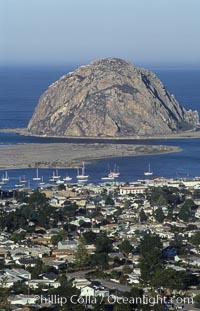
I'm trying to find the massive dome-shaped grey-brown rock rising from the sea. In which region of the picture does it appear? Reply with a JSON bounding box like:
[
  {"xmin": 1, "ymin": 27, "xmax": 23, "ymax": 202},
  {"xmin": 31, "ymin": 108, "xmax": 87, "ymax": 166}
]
[{"xmin": 28, "ymin": 58, "xmax": 199, "ymax": 137}]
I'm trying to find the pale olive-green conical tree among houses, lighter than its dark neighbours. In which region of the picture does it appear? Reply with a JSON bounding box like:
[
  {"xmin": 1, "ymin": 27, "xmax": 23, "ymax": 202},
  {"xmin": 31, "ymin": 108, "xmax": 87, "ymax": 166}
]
[{"xmin": 75, "ymin": 237, "xmax": 89, "ymax": 268}]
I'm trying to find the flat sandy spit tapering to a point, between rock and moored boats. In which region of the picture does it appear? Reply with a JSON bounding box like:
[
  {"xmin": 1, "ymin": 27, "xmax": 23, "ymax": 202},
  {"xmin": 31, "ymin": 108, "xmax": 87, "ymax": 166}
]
[{"xmin": 0, "ymin": 143, "xmax": 181, "ymax": 169}]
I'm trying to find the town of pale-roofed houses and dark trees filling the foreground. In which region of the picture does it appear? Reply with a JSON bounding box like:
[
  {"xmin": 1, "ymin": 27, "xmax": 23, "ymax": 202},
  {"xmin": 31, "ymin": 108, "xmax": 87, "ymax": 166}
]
[{"xmin": 0, "ymin": 177, "xmax": 200, "ymax": 311}]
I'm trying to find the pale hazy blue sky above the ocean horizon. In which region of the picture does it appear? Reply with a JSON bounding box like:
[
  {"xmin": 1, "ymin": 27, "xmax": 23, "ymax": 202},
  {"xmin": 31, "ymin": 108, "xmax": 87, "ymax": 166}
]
[{"xmin": 0, "ymin": 0, "xmax": 200, "ymax": 64}]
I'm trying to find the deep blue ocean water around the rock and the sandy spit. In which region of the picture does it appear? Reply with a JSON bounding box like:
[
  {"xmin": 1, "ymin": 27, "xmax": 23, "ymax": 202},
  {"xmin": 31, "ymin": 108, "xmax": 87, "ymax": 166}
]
[{"xmin": 0, "ymin": 66, "xmax": 200, "ymax": 189}]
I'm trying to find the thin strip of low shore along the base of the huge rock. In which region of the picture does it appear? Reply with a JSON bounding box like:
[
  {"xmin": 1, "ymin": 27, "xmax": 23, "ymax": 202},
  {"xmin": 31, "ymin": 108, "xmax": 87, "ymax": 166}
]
[{"xmin": 0, "ymin": 128, "xmax": 200, "ymax": 141}]
